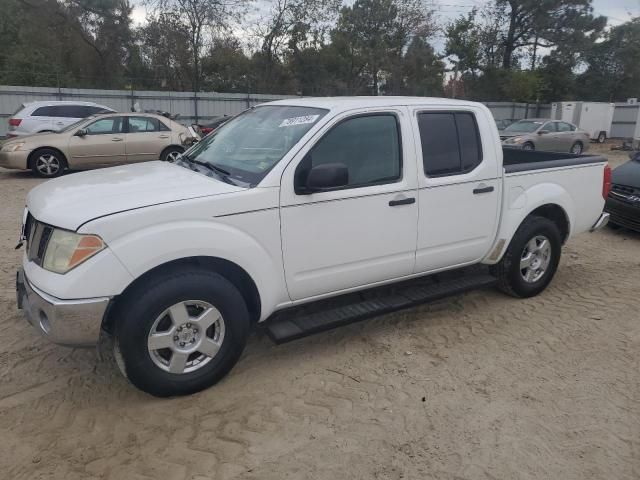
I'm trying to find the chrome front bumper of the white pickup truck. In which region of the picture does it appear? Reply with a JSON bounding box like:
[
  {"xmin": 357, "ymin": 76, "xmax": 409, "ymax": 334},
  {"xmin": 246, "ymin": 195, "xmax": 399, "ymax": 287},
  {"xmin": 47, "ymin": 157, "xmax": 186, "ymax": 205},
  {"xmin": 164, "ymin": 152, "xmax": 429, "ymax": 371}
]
[{"xmin": 16, "ymin": 270, "xmax": 111, "ymax": 347}]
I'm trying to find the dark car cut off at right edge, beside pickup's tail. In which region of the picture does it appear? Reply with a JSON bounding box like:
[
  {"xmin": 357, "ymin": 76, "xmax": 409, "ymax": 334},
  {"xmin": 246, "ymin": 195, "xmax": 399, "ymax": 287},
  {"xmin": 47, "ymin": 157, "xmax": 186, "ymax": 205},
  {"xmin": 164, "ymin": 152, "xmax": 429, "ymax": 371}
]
[{"xmin": 605, "ymin": 152, "xmax": 640, "ymax": 232}]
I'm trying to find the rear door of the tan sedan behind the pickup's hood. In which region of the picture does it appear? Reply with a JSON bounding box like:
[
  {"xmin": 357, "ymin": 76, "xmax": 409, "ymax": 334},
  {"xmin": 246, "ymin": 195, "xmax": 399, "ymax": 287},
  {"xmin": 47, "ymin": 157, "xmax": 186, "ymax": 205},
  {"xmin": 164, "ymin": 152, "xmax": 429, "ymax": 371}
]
[{"xmin": 126, "ymin": 116, "xmax": 171, "ymax": 162}]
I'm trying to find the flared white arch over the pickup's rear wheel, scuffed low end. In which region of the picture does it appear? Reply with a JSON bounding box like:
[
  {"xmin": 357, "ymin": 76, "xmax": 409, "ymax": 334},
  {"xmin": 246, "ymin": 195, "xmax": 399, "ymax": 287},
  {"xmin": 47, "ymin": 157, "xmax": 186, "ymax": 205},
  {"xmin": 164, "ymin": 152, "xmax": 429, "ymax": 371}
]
[{"xmin": 483, "ymin": 182, "xmax": 575, "ymax": 264}]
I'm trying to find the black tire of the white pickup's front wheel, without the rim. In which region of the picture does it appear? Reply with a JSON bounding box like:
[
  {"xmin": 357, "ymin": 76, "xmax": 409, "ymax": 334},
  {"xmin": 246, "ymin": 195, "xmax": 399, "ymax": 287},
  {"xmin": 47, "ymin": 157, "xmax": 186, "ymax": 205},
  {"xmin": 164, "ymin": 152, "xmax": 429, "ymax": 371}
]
[{"xmin": 114, "ymin": 268, "xmax": 250, "ymax": 397}]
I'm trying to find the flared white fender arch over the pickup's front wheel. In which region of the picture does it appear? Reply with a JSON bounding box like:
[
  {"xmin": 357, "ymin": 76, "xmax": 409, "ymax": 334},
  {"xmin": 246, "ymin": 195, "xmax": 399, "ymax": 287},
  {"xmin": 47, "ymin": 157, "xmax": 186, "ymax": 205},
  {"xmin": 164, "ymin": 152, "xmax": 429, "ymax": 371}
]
[{"xmin": 101, "ymin": 218, "xmax": 289, "ymax": 316}]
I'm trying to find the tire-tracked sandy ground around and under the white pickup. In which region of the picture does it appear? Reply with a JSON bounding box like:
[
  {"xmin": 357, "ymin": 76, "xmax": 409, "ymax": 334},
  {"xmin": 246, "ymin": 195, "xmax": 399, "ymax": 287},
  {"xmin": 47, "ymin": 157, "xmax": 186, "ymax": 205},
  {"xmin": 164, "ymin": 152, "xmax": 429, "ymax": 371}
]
[{"xmin": 0, "ymin": 143, "xmax": 640, "ymax": 480}]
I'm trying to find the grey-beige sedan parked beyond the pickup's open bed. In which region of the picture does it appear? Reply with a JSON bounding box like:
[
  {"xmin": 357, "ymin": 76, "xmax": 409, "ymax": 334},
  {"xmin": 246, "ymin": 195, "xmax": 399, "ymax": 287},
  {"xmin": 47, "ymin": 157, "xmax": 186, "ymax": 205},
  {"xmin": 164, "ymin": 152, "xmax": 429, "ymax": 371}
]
[{"xmin": 500, "ymin": 118, "xmax": 590, "ymax": 155}]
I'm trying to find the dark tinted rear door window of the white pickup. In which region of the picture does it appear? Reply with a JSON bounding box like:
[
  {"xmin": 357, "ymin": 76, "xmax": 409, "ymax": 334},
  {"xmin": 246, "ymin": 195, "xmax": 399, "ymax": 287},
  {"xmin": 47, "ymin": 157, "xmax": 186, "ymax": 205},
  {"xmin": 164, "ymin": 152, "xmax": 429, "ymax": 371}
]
[{"xmin": 418, "ymin": 112, "xmax": 482, "ymax": 177}]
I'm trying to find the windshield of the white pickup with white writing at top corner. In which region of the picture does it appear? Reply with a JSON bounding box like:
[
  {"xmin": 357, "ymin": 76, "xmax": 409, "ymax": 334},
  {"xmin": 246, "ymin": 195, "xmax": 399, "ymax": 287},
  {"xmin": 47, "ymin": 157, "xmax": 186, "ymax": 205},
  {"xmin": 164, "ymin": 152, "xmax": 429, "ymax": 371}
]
[{"xmin": 185, "ymin": 105, "xmax": 328, "ymax": 186}]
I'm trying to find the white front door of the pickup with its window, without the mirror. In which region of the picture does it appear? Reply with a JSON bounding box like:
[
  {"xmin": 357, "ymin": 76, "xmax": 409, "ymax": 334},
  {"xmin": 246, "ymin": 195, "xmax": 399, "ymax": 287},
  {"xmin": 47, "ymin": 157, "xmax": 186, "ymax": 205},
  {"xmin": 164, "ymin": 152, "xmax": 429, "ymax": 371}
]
[{"xmin": 280, "ymin": 109, "xmax": 418, "ymax": 300}]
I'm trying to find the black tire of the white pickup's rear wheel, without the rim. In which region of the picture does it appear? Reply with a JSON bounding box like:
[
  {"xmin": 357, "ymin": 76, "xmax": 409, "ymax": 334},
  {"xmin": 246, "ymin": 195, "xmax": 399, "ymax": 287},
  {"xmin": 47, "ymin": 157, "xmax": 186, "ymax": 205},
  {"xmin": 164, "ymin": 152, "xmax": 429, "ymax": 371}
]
[{"xmin": 491, "ymin": 216, "xmax": 562, "ymax": 298}]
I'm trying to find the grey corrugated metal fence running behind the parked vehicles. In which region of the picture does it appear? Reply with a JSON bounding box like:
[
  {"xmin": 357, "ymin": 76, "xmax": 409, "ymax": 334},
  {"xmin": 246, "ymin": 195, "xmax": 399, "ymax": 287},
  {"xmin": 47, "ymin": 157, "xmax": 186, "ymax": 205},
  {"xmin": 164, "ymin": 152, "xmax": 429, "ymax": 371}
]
[{"xmin": 0, "ymin": 86, "xmax": 640, "ymax": 138}]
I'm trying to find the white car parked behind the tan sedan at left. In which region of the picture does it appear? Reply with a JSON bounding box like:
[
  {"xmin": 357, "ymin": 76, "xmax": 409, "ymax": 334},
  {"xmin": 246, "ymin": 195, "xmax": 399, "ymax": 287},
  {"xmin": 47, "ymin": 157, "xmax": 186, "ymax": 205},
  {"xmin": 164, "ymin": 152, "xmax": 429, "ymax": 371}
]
[{"xmin": 7, "ymin": 101, "xmax": 114, "ymax": 137}]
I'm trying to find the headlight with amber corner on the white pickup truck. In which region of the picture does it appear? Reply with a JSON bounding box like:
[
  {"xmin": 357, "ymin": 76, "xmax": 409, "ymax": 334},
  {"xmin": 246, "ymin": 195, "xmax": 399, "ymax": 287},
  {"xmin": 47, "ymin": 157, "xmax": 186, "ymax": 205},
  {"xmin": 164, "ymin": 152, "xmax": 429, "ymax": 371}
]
[{"xmin": 42, "ymin": 228, "xmax": 105, "ymax": 273}]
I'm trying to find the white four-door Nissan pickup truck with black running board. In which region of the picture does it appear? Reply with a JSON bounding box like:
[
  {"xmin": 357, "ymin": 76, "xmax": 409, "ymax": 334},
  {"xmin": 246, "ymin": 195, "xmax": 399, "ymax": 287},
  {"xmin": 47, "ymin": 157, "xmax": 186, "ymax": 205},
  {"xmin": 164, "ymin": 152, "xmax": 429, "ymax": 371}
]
[{"xmin": 17, "ymin": 97, "xmax": 610, "ymax": 396}]
